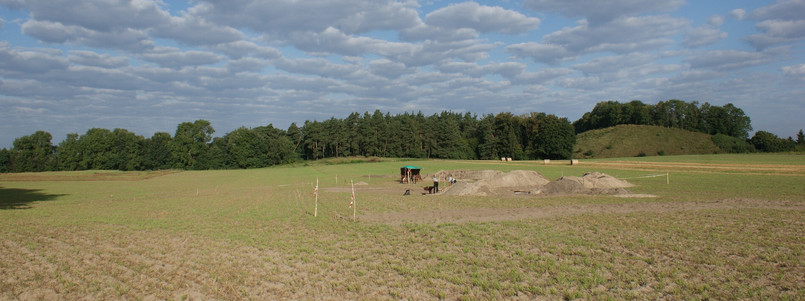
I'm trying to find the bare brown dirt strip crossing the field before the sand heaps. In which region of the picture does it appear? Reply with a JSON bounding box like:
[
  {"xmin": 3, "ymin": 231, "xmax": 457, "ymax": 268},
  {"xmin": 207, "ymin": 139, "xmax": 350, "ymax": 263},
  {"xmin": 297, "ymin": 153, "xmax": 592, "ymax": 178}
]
[{"xmin": 358, "ymin": 199, "xmax": 805, "ymax": 224}]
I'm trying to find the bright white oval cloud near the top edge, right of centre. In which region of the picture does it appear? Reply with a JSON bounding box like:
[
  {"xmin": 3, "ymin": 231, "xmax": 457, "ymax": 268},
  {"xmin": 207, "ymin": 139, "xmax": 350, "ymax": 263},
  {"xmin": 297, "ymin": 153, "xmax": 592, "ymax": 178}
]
[{"xmin": 425, "ymin": 2, "xmax": 540, "ymax": 33}]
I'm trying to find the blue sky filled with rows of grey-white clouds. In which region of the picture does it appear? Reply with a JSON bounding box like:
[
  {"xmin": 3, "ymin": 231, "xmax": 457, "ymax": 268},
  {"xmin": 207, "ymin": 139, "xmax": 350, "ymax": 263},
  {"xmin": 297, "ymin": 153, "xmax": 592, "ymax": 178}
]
[{"xmin": 0, "ymin": 0, "xmax": 805, "ymax": 148}]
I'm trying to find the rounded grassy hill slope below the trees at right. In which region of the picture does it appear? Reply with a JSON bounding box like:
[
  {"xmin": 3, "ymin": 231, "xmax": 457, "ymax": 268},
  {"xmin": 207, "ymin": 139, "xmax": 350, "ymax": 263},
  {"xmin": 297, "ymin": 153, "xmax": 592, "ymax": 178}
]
[{"xmin": 573, "ymin": 125, "xmax": 720, "ymax": 158}]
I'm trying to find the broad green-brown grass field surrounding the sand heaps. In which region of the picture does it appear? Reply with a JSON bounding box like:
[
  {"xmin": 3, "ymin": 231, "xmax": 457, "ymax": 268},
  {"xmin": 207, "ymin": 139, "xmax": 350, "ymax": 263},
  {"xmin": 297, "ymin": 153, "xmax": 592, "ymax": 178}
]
[{"xmin": 0, "ymin": 155, "xmax": 805, "ymax": 300}]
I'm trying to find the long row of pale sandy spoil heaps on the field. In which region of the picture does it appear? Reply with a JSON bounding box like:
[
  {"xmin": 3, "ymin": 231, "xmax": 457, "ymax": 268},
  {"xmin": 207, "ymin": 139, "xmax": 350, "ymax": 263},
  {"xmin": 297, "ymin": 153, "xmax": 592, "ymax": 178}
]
[{"xmin": 435, "ymin": 170, "xmax": 633, "ymax": 196}]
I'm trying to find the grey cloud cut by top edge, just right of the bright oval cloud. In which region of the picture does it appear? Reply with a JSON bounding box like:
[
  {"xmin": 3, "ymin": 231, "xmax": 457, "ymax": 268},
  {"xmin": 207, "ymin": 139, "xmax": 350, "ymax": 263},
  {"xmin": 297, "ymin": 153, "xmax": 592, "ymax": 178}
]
[{"xmin": 523, "ymin": 0, "xmax": 685, "ymax": 25}]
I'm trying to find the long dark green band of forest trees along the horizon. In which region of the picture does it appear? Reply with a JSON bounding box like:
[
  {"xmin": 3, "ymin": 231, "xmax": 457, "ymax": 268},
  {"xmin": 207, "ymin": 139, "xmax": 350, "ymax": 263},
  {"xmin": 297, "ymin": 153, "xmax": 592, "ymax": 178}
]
[{"xmin": 0, "ymin": 100, "xmax": 805, "ymax": 172}]
